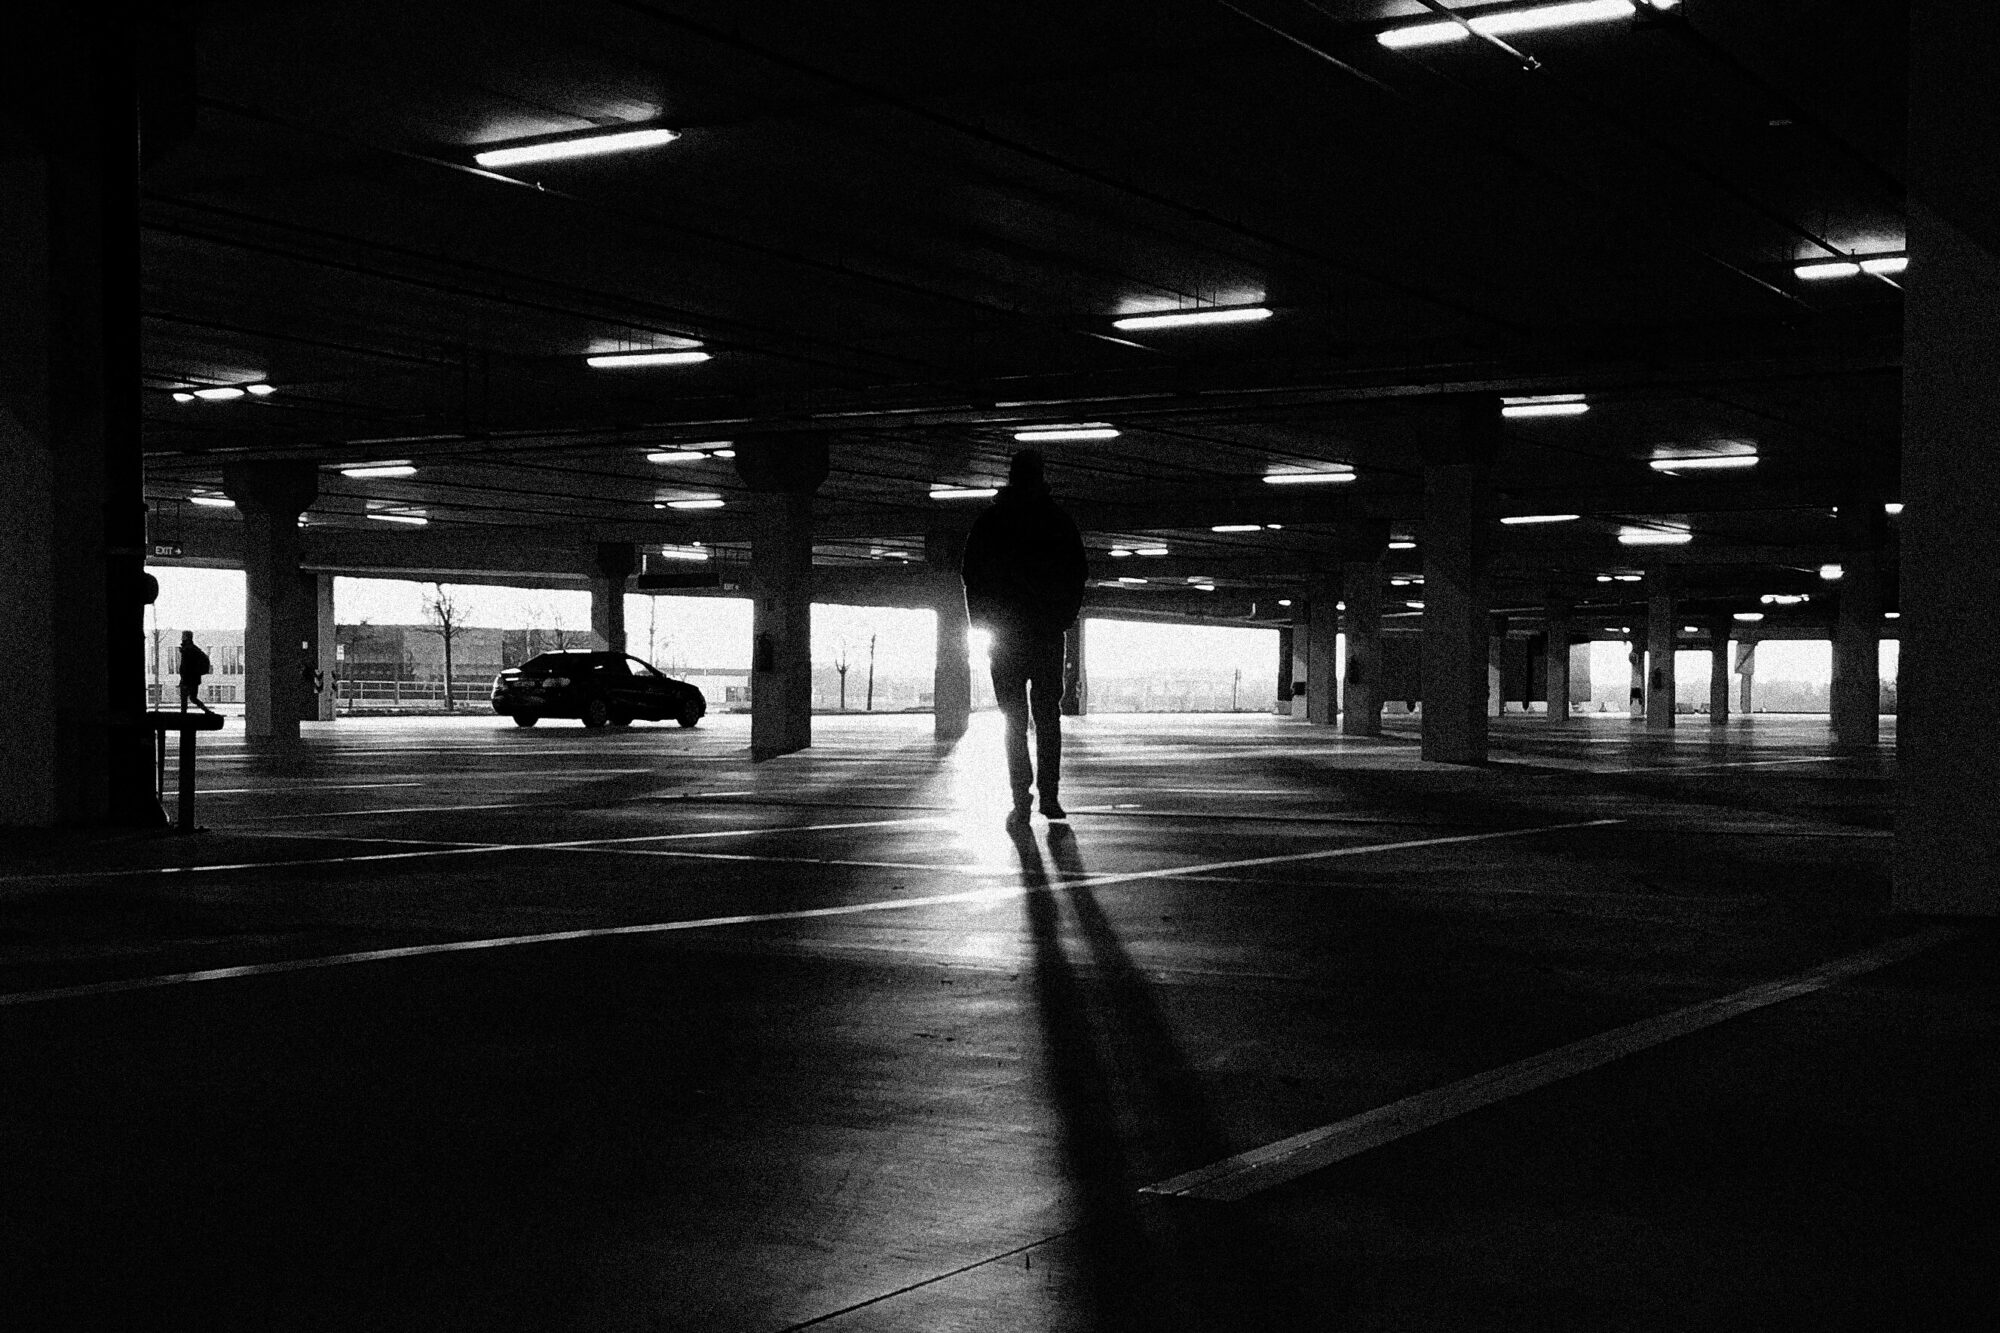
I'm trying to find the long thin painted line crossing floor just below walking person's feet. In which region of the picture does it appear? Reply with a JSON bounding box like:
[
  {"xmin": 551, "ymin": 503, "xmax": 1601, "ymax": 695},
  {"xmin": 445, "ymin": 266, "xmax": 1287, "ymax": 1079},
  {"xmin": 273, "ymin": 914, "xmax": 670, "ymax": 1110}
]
[{"xmin": 0, "ymin": 819, "xmax": 1622, "ymax": 1007}]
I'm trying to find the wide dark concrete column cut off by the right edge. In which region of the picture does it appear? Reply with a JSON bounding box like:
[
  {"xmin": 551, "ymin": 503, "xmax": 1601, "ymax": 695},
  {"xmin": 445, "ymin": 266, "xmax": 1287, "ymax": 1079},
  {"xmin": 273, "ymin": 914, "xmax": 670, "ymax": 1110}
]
[{"xmin": 1894, "ymin": 0, "xmax": 2000, "ymax": 917}]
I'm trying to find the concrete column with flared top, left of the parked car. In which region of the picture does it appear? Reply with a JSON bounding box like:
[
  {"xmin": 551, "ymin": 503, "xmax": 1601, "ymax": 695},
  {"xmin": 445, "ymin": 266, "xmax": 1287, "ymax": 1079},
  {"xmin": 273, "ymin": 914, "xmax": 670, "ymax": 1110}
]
[{"xmin": 222, "ymin": 462, "xmax": 320, "ymax": 743}]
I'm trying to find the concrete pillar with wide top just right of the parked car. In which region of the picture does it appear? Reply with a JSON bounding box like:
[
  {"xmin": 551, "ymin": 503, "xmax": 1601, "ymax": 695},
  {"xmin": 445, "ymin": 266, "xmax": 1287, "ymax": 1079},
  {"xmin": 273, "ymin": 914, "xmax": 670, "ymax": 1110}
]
[{"xmin": 736, "ymin": 434, "xmax": 828, "ymax": 763}]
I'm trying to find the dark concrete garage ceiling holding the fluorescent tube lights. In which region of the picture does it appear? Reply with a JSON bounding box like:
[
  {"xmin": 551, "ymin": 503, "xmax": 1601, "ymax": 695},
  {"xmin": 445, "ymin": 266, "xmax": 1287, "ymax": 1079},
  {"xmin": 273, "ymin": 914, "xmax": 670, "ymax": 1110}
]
[{"xmin": 142, "ymin": 0, "xmax": 1906, "ymax": 614}]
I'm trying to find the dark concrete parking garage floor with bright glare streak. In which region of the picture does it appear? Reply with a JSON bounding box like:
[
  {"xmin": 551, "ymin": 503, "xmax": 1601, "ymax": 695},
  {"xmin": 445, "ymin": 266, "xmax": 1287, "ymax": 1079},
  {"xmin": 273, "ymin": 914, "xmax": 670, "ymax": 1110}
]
[{"xmin": 0, "ymin": 715, "xmax": 2000, "ymax": 1333}]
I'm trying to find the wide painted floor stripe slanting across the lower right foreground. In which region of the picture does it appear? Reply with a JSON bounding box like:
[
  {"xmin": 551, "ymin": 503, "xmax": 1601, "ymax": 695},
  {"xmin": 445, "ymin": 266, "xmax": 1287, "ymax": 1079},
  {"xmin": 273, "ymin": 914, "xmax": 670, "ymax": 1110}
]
[{"xmin": 1140, "ymin": 927, "xmax": 1962, "ymax": 1203}]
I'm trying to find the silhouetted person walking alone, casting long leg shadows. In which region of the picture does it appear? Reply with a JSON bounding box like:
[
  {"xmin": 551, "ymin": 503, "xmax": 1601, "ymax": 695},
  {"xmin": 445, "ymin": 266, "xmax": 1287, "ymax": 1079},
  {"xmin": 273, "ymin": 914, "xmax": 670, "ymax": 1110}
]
[{"xmin": 962, "ymin": 448, "xmax": 1088, "ymax": 819}]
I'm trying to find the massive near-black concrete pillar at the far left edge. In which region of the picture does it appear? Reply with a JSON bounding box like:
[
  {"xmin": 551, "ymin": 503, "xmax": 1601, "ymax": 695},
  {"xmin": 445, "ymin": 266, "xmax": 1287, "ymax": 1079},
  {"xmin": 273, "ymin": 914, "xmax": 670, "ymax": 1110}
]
[{"xmin": 0, "ymin": 23, "xmax": 166, "ymax": 827}]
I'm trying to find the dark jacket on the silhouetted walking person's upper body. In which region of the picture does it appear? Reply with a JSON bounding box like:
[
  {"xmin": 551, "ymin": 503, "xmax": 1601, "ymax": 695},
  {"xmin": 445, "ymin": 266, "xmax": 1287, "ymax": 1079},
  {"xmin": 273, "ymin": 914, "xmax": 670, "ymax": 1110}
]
[{"xmin": 962, "ymin": 486, "xmax": 1090, "ymax": 642}]
